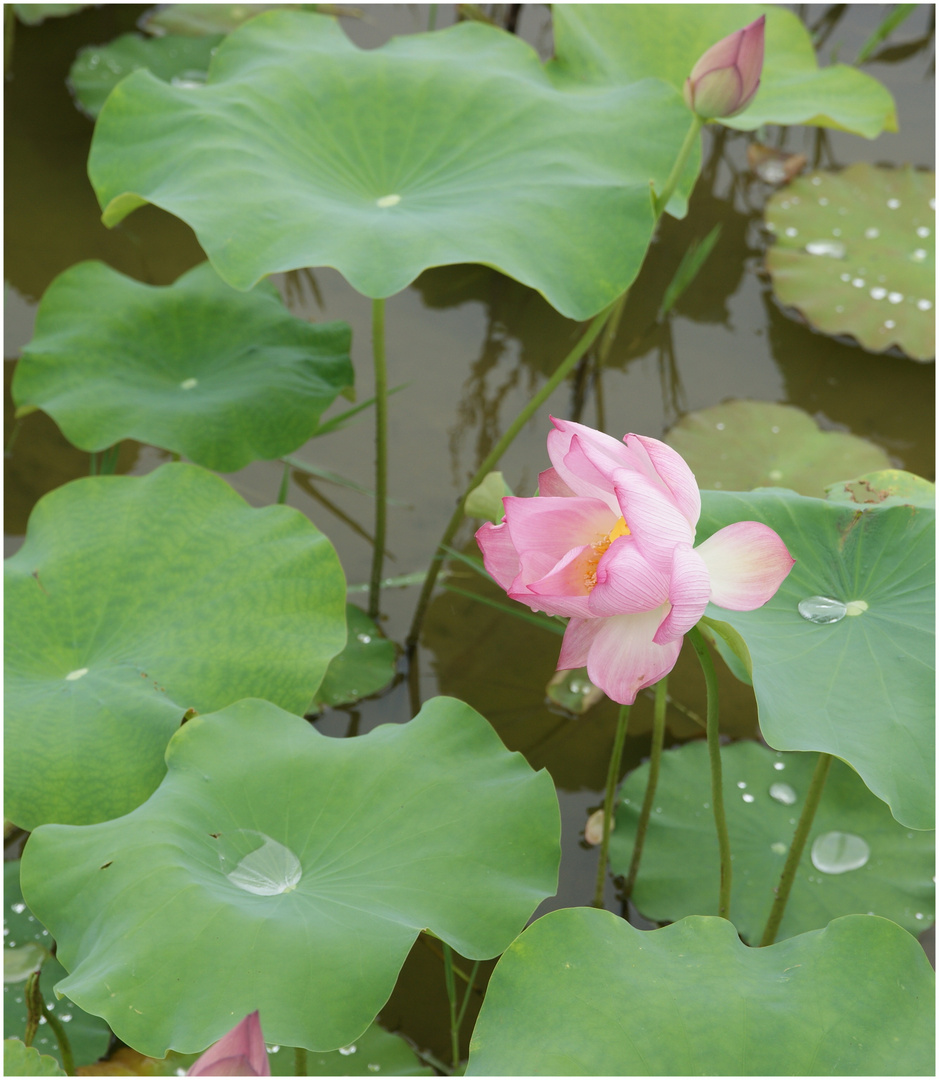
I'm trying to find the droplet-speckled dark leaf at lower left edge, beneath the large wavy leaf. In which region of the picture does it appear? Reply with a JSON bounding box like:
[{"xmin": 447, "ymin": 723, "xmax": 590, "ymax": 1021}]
[{"xmin": 3, "ymin": 859, "xmax": 111, "ymax": 1076}]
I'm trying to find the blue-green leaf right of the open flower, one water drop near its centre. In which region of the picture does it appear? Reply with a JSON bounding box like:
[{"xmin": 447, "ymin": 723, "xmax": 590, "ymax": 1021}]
[{"xmin": 698, "ymin": 490, "xmax": 935, "ymax": 829}]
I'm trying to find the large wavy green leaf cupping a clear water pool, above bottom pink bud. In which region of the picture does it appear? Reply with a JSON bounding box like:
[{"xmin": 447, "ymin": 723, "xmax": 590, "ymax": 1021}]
[{"xmin": 22, "ymin": 698, "xmax": 560, "ymax": 1056}]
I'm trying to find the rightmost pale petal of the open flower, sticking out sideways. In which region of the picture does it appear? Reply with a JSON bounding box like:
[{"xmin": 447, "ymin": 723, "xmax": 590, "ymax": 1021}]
[{"xmin": 695, "ymin": 522, "xmax": 795, "ymax": 611}]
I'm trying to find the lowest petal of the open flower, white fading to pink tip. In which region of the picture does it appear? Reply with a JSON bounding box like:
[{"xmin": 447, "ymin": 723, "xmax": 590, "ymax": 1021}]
[{"xmin": 578, "ymin": 605, "xmax": 682, "ymax": 705}]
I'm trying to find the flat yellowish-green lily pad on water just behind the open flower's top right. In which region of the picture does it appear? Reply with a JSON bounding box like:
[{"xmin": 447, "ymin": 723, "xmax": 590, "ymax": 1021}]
[{"xmin": 666, "ymin": 401, "xmax": 890, "ymax": 498}]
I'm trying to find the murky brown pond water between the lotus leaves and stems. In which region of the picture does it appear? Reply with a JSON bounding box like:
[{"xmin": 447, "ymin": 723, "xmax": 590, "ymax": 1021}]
[{"xmin": 5, "ymin": 4, "xmax": 935, "ymax": 1056}]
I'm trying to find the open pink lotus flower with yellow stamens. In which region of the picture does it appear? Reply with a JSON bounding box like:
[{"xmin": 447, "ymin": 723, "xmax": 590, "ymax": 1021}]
[{"xmin": 477, "ymin": 417, "xmax": 794, "ymax": 705}]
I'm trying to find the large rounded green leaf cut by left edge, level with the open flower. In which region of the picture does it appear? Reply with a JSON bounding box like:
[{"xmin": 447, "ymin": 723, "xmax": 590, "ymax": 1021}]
[{"xmin": 4, "ymin": 464, "xmax": 346, "ymax": 825}]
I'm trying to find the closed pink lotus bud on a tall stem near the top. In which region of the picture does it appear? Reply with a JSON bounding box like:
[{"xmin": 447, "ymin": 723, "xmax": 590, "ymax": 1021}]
[{"xmin": 684, "ymin": 15, "xmax": 766, "ymax": 120}]
